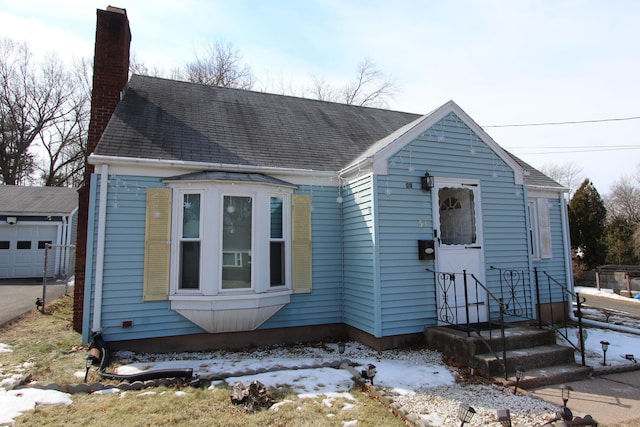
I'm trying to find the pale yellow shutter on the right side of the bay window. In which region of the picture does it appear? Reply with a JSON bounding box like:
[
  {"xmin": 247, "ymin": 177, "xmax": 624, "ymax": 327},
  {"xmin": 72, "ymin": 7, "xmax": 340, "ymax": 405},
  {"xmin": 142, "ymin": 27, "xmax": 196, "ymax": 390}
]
[{"xmin": 291, "ymin": 194, "xmax": 312, "ymax": 294}]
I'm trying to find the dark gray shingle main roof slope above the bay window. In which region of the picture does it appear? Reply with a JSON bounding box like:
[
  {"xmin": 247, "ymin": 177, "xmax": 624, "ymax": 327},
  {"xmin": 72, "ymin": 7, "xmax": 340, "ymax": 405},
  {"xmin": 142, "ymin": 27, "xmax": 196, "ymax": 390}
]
[{"xmin": 95, "ymin": 75, "xmax": 419, "ymax": 171}]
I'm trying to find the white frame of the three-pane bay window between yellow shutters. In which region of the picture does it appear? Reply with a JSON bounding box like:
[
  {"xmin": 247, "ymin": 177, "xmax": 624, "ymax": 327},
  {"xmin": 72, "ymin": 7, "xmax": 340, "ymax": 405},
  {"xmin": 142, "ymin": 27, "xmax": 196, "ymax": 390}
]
[{"xmin": 169, "ymin": 181, "xmax": 293, "ymax": 301}]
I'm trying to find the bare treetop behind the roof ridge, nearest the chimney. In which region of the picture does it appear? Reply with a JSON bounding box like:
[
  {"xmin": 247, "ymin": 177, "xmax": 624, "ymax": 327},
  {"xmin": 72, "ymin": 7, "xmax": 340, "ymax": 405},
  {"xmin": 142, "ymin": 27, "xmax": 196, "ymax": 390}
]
[{"xmin": 185, "ymin": 42, "xmax": 254, "ymax": 89}]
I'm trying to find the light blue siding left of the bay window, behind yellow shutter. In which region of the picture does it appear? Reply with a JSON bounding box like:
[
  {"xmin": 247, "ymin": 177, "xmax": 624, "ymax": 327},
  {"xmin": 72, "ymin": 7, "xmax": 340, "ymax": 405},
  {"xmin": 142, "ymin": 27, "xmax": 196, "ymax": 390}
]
[{"xmin": 83, "ymin": 175, "xmax": 202, "ymax": 341}]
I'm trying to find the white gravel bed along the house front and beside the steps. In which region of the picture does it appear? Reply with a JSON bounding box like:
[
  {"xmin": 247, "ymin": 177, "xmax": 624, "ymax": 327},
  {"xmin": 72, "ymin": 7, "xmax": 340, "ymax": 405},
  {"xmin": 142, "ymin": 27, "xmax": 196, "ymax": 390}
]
[{"xmin": 117, "ymin": 342, "xmax": 559, "ymax": 426}]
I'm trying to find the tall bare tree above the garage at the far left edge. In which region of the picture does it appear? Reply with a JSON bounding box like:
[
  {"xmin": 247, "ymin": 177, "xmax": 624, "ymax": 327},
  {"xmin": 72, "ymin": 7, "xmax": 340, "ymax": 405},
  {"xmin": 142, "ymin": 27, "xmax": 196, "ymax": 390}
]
[{"xmin": 0, "ymin": 39, "xmax": 86, "ymax": 185}]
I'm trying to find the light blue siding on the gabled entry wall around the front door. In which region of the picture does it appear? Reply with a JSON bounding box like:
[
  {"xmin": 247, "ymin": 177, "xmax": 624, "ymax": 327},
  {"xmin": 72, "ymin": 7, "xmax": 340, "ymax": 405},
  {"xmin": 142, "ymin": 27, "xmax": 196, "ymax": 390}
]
[{"xmin": 376, "ymin": 113, "xmax": 529, "ymax": 336}]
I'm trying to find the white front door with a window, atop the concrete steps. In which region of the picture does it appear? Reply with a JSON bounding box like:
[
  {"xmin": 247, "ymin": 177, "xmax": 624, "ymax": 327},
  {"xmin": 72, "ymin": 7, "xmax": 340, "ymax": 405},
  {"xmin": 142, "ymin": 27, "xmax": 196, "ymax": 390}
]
[{"xmin": 432, "ymin": 179, "xmax": 488, "ymax": 324}]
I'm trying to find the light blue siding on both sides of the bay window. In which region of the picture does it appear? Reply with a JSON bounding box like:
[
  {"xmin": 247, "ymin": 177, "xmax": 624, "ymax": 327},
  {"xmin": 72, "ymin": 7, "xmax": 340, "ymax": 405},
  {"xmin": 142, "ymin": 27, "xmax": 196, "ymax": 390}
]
[{"xmin": 86, "ymin": 176, "xmax": 342, "ymax": 340}]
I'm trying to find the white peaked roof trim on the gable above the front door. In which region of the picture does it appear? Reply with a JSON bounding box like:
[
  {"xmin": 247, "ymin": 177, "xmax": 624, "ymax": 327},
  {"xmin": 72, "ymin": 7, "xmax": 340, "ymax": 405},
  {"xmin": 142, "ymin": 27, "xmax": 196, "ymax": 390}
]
[{"xmin": 338, "ymin": 101, "xmax": 524, "ymax": 185}]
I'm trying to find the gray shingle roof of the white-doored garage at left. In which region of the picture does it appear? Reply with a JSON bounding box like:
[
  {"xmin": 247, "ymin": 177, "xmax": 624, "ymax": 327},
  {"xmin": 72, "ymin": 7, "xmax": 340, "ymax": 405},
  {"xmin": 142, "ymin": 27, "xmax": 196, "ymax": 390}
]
[{"xmin": 0, "ymin": 185, "xmax": 78, "ymax": 215}]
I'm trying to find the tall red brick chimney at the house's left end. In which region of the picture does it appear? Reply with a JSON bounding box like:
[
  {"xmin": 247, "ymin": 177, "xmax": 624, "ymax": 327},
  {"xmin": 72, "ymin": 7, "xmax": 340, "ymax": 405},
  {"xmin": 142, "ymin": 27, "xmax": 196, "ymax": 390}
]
[{"xmin": 73, "ymin": 6, "xmax": 131, "ymax": 332}]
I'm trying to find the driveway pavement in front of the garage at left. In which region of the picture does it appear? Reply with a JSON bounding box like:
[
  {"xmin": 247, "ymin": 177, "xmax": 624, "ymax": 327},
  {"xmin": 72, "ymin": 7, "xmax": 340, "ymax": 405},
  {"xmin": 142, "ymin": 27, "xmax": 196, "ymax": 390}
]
[{"xmin": 0, "ymin": 278, "xmax": 70, "ymax": 326}]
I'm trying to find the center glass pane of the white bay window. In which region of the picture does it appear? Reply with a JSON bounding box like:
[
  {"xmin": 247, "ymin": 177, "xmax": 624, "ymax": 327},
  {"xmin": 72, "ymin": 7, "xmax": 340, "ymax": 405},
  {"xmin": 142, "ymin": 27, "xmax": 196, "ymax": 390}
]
[{"xmin": 222, "ymin": 196, "xmax": 253, "ymax": 289}]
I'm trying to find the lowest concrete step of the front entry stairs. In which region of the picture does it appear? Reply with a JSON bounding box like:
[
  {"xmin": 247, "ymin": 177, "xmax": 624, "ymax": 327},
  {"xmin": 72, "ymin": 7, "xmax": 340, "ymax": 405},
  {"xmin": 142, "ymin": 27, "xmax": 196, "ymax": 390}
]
[{"xmin": 495, "ymin": 363, "xmax": 593, "ymax": 390}]
